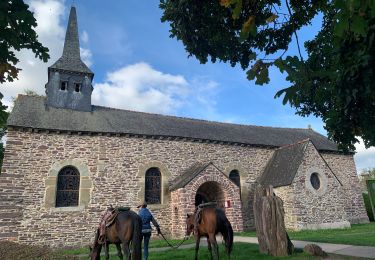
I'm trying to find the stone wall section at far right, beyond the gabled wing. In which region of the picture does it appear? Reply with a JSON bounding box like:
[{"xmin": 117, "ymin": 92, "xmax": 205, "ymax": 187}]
[{"xmin": 322, "ymin": 153, "xmax": 369, "ymax": 224}]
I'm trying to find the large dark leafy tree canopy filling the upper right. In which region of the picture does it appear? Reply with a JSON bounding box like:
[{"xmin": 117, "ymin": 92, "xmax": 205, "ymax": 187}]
[{"xmin": 160, "ymin": 0, "xmax": 375, "ymax": 150}]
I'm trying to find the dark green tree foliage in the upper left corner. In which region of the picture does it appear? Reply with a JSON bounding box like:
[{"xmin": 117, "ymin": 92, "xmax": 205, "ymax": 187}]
[{"xmin": 0, "ymin": 0, "xmax": 49, "ymax": 83}]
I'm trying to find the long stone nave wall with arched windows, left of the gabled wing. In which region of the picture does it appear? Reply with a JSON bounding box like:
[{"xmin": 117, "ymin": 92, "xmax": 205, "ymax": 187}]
[{"xmin": 0, "ymin": 129, "xmax": 272, "ymax": 246}]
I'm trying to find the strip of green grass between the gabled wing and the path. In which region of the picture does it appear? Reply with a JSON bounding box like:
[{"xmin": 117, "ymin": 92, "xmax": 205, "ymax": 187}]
[{"xmin": 237, "ymin": 223, "xmax": 375, "ymax": 246}]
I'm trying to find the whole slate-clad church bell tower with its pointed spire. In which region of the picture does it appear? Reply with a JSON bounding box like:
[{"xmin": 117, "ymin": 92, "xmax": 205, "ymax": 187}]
[{"xmin": 46, "ymin": 6, "xmax": 94, "ymax": 112}]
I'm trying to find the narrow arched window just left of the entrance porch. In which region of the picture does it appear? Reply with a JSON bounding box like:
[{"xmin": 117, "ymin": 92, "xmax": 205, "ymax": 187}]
[{"xmin": 145, "ymin": 167, "xmax": 161, "ymax": 204}]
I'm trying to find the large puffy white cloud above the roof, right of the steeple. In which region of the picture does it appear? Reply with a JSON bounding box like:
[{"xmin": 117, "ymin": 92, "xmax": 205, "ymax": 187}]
[{"xmin": 92, "ymin": 62, "xmax": 217, "ymax": 116}]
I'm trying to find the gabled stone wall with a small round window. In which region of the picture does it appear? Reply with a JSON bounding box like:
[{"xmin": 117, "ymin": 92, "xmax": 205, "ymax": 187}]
[{"xmin": 275, "ymin": 142, "xmax": 350, "ymax": 230}]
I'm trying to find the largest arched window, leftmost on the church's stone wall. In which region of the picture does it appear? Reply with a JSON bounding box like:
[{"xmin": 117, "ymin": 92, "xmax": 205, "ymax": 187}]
[{"xmin": 56, "ymin": 166, "xmax": 80, "ymax": 207}]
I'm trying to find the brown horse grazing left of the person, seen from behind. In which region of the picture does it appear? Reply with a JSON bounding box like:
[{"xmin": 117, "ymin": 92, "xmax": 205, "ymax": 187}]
[{"xmin": 90, "ymin": 210, "xmax": 142, "ymax": 260}]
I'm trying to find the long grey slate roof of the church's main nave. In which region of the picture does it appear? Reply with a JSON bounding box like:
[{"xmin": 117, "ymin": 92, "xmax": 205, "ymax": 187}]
[{"xmin": 8, "ymin": 95, "xmax": 338, "ymax": 152}]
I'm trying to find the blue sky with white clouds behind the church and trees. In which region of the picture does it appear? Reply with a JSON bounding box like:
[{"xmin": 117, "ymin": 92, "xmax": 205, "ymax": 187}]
[{"xmin": 0, "ymin": 0, "xmax": 375, "ymax": 171}]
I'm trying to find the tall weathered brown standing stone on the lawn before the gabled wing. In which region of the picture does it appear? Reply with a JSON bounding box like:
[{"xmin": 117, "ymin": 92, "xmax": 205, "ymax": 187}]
[{"xmin": 253, "ymin": 185, "xmax": 294, "ymax": 256}]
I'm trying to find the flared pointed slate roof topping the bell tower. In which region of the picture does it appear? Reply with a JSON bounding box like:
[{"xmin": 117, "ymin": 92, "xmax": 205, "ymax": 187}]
[{"xmin": 49, "ymin": 7, "xmax": 94, "ymax": 75}]
